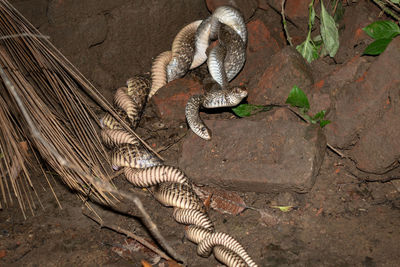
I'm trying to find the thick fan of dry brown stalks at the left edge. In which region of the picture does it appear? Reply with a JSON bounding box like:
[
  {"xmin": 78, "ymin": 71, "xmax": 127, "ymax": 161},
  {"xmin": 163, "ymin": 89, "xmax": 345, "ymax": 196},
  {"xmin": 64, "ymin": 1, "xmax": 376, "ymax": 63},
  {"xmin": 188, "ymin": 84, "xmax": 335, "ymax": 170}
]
[{"xmin": 0, "ymin": 1, "xmax": 115, "ymax": 216}]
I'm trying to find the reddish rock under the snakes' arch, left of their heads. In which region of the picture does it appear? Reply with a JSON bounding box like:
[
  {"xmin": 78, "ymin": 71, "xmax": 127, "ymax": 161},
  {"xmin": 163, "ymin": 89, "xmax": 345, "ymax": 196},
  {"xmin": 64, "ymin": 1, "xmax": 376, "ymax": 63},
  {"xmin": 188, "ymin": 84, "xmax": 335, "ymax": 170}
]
[{"xmin": 151, "ymin": 78, "xmax": 203, "ymax": 121}]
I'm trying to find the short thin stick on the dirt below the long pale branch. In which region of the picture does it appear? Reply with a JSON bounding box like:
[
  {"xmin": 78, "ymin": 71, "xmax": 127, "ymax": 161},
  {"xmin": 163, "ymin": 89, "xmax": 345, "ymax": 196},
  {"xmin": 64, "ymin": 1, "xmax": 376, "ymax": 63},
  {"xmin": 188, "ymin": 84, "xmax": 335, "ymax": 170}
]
[{"xmin": 82, "ymin": 206, "xmax": 172, "ymax": 260}]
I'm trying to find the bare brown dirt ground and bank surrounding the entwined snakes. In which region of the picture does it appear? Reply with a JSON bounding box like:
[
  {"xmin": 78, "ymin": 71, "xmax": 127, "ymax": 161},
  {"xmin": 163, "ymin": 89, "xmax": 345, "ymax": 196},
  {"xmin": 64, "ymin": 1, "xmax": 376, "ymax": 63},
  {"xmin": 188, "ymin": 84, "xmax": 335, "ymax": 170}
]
[{"xmin": 0, "ymin": 0, "xmax": 400, "ymax": 267}]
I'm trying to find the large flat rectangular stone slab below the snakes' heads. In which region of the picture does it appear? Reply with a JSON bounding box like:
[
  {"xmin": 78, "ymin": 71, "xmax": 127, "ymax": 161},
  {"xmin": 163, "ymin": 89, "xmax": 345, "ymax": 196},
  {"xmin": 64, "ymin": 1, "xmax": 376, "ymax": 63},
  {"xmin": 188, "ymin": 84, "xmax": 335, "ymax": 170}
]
[{"xmin": 179, "ymin": 109, "xmax": 326, "ymax": 192}]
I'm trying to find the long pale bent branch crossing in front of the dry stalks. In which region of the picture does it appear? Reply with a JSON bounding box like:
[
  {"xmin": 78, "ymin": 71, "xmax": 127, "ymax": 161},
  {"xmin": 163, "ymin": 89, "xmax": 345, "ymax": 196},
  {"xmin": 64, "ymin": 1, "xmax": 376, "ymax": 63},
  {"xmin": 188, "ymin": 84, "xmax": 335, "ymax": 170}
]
[{"xmin": 0, "ymin": 67, "xmax": 184, "ymax": 262}]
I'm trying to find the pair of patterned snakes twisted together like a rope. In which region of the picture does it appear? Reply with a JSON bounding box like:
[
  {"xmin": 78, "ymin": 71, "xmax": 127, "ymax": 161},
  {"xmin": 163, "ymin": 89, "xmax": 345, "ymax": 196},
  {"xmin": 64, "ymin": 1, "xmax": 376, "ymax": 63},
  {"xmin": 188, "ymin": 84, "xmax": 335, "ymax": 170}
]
[{"xmin": 100, "ymin": 6, "xmax": 257, "ymax": 266}]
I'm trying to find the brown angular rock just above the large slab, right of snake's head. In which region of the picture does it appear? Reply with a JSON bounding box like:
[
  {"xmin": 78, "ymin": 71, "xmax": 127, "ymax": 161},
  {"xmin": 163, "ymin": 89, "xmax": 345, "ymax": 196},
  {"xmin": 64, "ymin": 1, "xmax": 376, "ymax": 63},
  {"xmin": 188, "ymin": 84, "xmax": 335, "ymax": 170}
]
[{"xmin": 248, "ymin": 46, "xmax": 313, "ymax": 105}]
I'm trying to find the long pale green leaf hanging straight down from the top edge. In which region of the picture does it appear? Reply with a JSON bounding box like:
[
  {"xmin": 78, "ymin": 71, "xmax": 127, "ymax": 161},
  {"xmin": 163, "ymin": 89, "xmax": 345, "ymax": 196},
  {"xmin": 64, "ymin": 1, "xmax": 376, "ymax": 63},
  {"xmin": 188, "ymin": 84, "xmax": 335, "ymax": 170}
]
[{"xmin": 321, "ymin": 1, "xmax": 339, "ymax": 57}]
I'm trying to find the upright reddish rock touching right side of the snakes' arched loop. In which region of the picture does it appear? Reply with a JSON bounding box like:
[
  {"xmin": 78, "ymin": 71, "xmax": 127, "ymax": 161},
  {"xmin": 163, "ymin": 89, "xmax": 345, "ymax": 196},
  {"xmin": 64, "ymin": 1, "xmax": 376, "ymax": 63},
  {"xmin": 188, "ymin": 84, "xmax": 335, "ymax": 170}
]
[{"xmin": 234, "ymin": 19, "xmax": 282, "ymax": 85}]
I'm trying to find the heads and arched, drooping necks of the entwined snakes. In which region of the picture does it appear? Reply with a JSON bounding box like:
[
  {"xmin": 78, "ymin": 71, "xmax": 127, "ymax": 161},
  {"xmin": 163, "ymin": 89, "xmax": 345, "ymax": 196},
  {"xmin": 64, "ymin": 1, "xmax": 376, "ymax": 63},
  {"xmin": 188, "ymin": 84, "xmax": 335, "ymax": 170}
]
[{"xmin": 185, "ymin": 6, "xmax": 247, "ymax": 140}]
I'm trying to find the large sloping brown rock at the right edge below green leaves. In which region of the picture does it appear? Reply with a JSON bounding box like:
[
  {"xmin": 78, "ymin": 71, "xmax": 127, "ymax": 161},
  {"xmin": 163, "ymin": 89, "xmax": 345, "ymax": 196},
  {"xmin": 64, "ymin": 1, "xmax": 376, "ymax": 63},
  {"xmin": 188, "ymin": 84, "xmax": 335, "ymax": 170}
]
[{"xmin": 326, "ymin": 37, "xmax": 400, "ymax": 149}]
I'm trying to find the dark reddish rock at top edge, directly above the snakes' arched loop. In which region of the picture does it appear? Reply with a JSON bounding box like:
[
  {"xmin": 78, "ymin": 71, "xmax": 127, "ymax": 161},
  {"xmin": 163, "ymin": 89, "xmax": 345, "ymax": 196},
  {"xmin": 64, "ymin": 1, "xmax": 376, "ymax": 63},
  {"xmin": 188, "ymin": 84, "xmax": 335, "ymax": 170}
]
[{"xmin": 206, "ymin": 0, "xmax": 258, "ymax": 20}]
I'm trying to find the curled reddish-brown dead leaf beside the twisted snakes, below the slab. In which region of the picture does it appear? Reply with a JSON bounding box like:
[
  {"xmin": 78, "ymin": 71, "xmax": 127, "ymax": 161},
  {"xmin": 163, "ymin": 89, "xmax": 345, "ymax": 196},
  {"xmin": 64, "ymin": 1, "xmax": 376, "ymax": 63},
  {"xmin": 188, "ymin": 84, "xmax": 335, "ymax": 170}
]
[{"xmin": 193, "ymin": 186, "xmax": 247, "ymax": 215}]
